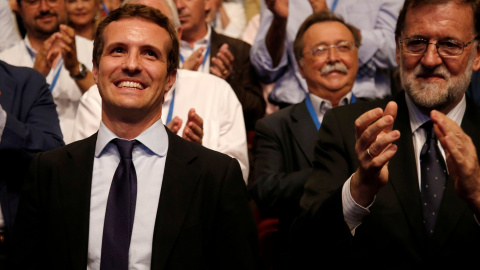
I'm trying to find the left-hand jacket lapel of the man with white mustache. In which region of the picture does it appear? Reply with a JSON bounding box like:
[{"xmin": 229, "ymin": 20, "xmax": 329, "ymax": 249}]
[{"xmin": 290, "ymin": 100, "xmax": 318, "ymax": 166}]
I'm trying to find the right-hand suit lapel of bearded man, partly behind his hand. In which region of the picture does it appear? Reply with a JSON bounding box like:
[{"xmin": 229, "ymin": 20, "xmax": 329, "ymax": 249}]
[{"xmin": 433, "ymin": 99, "xmax": 480, "ymax": 245}]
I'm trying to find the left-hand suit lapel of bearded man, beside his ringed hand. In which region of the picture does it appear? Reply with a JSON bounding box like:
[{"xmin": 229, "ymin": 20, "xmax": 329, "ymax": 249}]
[{"xmin": 388, "ymin": 91, "xmax": 425, "ymax": 243}]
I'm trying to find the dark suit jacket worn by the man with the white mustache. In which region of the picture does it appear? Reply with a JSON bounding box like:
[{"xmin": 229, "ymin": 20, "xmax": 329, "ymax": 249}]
[{"xmin": 249, "ymin": 100, "xmax": 318, "ymax": 224}]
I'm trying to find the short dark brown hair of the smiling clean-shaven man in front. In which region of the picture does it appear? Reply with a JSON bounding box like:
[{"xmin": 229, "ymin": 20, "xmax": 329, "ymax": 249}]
[{"xmin": 93, "ymin": 4, "xmax": 180, "ymax": 72}]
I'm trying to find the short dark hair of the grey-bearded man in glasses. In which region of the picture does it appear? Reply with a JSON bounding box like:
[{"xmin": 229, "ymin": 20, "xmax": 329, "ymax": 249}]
[{"xmin": 395, "ymin": 0, "xmax": 480, "ymax": 37}]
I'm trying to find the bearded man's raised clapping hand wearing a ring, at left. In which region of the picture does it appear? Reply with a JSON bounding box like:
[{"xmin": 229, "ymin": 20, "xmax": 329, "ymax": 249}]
[{"xmin": 350, "ymin": 102, "xmax": 400, "ymax": 207}]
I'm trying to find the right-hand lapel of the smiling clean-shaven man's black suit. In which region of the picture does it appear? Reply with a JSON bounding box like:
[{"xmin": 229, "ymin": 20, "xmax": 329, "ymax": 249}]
[{"xmin": 151, "ymin": 129, "xmax": 200, "ymax": 269}]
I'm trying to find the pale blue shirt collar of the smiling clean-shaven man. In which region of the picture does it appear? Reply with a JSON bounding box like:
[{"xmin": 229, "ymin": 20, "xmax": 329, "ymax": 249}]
[{"xmin": 95, "ymin": 119, "xmax": 168, "ymax": 158}]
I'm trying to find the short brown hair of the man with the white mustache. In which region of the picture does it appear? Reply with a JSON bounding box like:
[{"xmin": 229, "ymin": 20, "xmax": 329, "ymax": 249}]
[{"xmin": 293, "ymin": 11, "xmax": 360, "ymax": 61}]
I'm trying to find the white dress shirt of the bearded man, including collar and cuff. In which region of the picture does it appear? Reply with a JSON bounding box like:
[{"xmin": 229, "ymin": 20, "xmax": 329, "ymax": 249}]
[{"xmin": 342, "ymin": 93, "xmax": 467, "ymax": 234}]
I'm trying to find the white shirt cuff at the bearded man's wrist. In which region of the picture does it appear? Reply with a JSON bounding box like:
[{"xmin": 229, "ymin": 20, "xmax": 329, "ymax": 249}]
[{"xmin": 342, "ymin": 174, "xmax": 375, "ymax": 235}]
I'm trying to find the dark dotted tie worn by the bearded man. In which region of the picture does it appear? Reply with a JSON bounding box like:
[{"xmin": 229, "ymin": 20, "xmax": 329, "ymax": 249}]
[{"xmin": 420, "ymin": 121, "xmax": 447, "ymax": 235}]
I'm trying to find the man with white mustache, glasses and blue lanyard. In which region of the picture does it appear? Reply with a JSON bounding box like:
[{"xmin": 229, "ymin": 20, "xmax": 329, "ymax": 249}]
[{"xmin": 250, "ymin": 12, "xmax": 360, "ymax": 269}]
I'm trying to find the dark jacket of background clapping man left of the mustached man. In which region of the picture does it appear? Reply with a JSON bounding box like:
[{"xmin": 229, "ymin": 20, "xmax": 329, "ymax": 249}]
[{"xmin": 210, "ymin": 29, "xmax": 266, "ymax": 130}]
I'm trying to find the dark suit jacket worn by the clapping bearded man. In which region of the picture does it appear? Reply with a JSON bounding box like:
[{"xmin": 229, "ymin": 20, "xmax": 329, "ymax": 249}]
[{"xmin": 292, "ymin": 91, "xmax": 480, "ymax": 269}]
